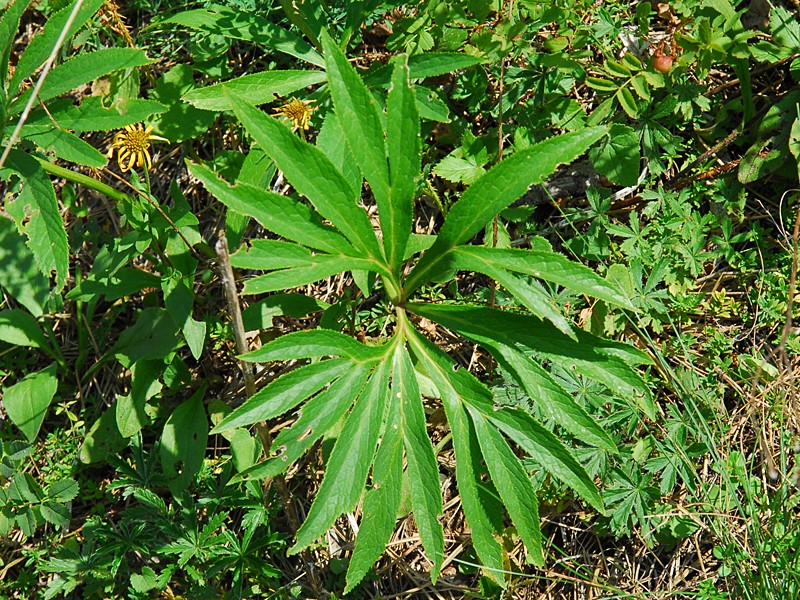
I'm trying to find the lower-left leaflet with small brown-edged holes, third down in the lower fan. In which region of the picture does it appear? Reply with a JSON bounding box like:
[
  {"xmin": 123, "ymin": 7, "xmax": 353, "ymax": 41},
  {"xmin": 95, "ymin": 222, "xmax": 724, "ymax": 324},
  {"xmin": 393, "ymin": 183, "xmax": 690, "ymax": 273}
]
[{"xmin": 230, "ymin": 365, "xmax": 372, "ymax": 480}]
